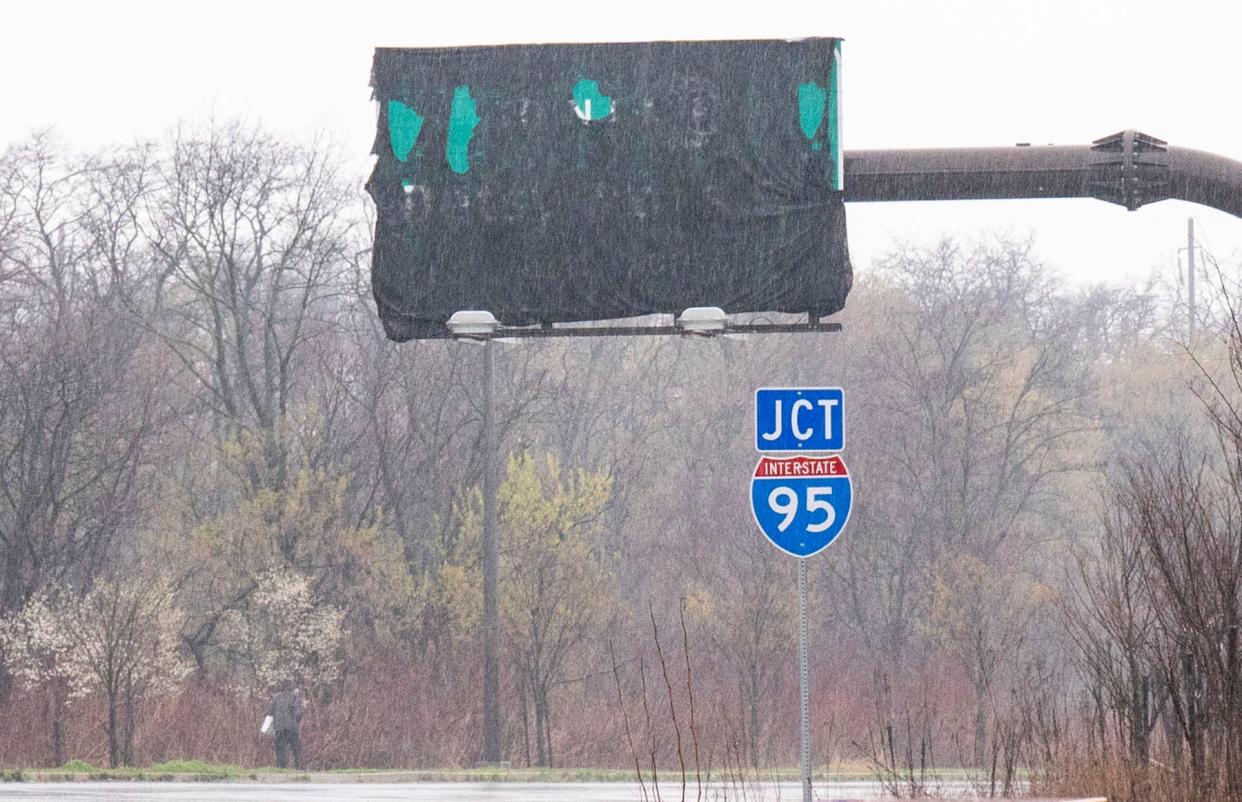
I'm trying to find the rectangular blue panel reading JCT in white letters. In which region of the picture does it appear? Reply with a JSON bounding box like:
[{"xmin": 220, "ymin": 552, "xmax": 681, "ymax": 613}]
[{"xmin": 755, "ymin": 387, "xmax": 845, "ymax": 452}]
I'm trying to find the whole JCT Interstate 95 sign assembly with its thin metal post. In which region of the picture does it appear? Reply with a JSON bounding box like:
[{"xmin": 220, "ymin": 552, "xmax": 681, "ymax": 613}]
[{"xmin": 750, "ymin": 387, "xmax": 853, "ymax": 802}]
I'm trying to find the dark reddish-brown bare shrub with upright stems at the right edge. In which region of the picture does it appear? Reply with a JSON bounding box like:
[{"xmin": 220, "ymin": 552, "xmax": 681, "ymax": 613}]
[{"xmin": 1067, "ymin": 260, "xmax": 1242, "ymax": 800}]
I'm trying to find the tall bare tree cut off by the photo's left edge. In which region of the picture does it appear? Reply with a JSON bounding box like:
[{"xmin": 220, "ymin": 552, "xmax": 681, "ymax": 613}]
[{"xmin": 0, "ymin": 137, "xmax": 160, "ymax": 610}]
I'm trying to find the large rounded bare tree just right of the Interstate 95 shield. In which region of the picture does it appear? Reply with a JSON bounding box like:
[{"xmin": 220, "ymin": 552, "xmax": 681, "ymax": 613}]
[{"xmin": 833, "ymin": 242, "xmax": 1094, "ymax": 668}]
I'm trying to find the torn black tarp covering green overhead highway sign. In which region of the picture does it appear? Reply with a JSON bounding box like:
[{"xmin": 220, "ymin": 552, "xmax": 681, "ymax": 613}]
[{"xmin": 368, "ymin": 38, "xmax": 852, "ymax": 340}]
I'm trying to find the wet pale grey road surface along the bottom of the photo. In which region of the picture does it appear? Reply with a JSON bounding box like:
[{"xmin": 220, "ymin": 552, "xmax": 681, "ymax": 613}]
[{"xmin": 0, "ymin": 782, "xmax": 948, "ymax": 802}]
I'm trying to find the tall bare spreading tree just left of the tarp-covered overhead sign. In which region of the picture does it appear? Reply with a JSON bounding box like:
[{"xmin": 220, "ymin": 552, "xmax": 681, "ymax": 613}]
[{"xmin": 147, "ymin": 124, "xmax": 356, "ymax": 489}]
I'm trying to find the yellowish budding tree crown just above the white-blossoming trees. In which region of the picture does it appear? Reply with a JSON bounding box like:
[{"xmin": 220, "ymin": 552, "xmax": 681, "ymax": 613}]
[{"xmin": 148, "ymin": 437, "xmax": 412, "ymax": 670}]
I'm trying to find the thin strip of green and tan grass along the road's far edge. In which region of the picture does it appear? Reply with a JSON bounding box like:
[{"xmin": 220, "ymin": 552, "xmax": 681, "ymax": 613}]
[{"xmin": 0, "ymin": 760, "xmax": 977, "ymax": 782}]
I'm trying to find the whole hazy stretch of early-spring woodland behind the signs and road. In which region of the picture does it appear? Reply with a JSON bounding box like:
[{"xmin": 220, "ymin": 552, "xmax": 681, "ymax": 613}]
[{"xmin": 0, "ymin": 125, "xmax": 1242, "ymax": 798}]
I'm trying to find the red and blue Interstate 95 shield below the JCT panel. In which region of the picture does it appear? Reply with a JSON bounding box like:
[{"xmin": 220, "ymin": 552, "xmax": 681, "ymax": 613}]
[{"xmin": 750, "ymin": 454, "xmax": 853, "ymax": 557}]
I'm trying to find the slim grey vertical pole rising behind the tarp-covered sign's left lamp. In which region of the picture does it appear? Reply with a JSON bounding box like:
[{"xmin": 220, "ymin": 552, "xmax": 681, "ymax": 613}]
[{"xmin": 483, "ymin": 338, "xmax": 501, "ymax": 765}]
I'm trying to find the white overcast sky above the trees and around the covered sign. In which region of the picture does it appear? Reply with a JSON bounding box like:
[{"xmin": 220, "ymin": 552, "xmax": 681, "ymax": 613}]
[{"xmin": 0, "ymin": 0, "xmax": 1242, "ymax": 289}]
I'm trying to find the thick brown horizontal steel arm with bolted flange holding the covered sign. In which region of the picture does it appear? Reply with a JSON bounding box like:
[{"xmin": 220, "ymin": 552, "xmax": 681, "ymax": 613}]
[{"xmin": 845, "ymin": 130, "xmax": 1242, "ymax": 217}]
